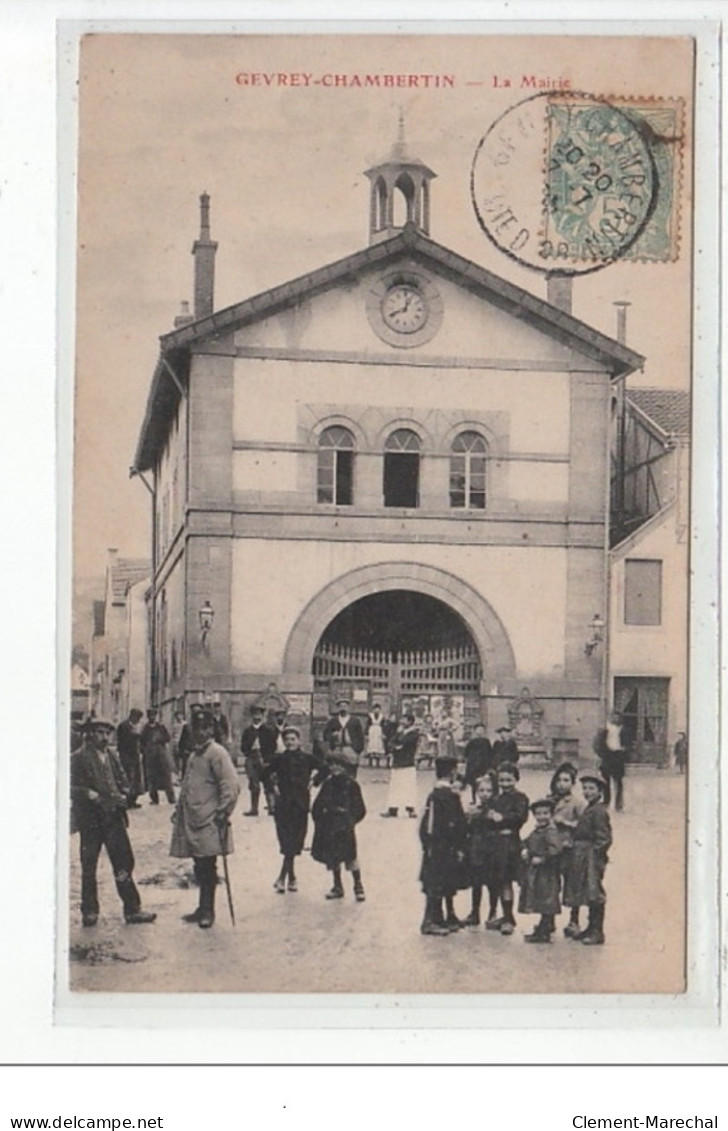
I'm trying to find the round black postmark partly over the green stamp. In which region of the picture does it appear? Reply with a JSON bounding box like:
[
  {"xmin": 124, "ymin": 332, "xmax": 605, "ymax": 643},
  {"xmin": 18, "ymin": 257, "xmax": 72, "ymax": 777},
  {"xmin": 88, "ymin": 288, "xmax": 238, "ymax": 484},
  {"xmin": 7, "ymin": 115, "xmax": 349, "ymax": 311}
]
[{"xmin": 470, "ymin": 90, "xmax": 658, "ymax": 275}]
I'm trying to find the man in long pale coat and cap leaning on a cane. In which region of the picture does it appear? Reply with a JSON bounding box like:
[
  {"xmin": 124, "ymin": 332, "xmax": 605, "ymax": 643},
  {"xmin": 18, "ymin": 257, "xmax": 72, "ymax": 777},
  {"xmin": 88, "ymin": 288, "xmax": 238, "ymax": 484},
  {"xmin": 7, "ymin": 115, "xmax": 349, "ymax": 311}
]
[{"xmin": 170, "ymin": 707, "xmax": 240, "ymax": 927}]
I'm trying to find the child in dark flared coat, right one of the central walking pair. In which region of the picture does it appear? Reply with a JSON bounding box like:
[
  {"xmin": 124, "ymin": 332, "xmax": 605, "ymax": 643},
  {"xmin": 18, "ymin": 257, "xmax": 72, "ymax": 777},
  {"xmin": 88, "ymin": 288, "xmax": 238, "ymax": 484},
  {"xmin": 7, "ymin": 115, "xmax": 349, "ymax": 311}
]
[{"xmin": 311, "ymin": 754, "xmax": 366, "ymax": 904}]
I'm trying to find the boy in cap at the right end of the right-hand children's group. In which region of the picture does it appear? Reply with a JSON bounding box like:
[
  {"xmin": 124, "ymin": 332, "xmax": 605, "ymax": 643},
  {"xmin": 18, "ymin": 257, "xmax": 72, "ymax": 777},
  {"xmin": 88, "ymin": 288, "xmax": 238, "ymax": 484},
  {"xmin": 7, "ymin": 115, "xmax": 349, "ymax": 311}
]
[{"xmin": 564, "ymin": 774, "xmax": 612, "ymax": 947}]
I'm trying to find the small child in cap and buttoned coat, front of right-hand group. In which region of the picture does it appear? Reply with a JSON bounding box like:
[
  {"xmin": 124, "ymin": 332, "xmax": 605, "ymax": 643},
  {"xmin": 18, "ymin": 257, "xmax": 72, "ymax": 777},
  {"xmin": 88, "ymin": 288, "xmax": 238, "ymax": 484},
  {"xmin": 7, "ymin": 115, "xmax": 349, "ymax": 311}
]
[{"xmin": 518, "ymin": 797, "xmax": 561, "ymax": 942}]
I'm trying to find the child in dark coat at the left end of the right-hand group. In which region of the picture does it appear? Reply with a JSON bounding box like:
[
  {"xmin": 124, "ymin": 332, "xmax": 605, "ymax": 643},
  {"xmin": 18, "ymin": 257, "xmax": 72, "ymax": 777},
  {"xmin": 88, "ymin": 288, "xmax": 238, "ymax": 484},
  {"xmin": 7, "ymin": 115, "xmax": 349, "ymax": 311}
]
[{"xmin": 419, "ymin": 754, "xmax": 467, "ymax": 935}]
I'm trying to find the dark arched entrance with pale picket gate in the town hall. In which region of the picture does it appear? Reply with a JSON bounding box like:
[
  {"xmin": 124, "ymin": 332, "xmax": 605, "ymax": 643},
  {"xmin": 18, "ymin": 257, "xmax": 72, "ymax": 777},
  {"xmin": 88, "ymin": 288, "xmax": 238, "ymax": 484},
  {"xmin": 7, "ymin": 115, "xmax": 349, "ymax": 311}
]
[{"xmin": 313, "ymin": 589, "xmax": 483, "ymax": 733}]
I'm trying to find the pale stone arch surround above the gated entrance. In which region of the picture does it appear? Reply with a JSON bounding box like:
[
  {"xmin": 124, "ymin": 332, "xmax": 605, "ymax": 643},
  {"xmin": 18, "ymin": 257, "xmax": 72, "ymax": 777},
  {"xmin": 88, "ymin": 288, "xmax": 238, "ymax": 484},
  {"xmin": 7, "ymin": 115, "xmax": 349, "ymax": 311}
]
[{"xmin": 284, "ymin": 562, "xmax": 515, "ymax": 683}]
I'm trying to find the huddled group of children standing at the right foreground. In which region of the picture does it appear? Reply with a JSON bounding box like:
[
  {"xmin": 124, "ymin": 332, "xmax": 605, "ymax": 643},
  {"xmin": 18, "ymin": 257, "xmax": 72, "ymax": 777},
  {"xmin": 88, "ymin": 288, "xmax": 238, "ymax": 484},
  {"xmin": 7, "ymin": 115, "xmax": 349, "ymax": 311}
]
[{"xmin": 421, "ymin": 758, "xmax": 612, "ymax": 946}]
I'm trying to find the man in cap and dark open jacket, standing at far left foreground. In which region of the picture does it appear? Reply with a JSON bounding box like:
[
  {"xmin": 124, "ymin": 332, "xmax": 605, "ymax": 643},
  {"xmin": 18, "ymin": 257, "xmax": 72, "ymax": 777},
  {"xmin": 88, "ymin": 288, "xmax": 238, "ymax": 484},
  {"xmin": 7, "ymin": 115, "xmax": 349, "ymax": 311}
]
[{"xmin": 70, "ymin": 718, "xmax": 157, "ymax": 926}]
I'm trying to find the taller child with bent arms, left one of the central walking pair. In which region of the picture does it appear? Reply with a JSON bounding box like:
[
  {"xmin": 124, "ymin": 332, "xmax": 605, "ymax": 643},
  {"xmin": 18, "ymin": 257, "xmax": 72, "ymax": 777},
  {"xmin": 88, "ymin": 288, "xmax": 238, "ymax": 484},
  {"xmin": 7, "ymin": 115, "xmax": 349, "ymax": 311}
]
[{"xmin": 260, "ymin": 726, "xmax": 323, "ymax": 895}]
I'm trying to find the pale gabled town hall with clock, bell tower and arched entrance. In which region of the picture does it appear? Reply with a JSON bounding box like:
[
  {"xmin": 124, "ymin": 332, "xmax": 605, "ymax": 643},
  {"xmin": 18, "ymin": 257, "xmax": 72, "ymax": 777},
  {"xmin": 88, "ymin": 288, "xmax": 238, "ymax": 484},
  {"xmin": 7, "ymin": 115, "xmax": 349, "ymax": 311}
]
[{"xmin": 135, "ymin": 128, "xmax": 644, "ymax": 754}]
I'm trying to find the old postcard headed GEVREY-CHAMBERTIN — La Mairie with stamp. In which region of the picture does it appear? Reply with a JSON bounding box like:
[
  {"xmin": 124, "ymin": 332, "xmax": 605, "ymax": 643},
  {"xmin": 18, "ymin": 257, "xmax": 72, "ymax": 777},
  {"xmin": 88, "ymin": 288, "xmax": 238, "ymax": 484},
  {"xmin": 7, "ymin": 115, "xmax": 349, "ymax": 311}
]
[{"xmin": 61, "ymin": 31, "xmax": 714, "ymax": 1001}]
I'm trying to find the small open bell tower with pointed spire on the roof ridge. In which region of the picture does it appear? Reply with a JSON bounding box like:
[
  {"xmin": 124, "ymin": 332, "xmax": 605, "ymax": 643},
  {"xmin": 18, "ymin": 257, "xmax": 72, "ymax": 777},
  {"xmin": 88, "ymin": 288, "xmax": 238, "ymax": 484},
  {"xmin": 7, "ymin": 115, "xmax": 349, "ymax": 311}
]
[{"xmin": 365, "ymin": 110, "xmax": 437, "ymax": 243}]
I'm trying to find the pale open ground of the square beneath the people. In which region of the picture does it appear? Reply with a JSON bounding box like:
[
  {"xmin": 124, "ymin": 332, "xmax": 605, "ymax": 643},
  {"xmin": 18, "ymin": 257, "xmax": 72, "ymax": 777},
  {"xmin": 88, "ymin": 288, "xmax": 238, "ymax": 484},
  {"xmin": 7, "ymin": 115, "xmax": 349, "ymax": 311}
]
[{"xmin": 65, "ymin": 769, "xmax": 685, "ymax": 994}]
